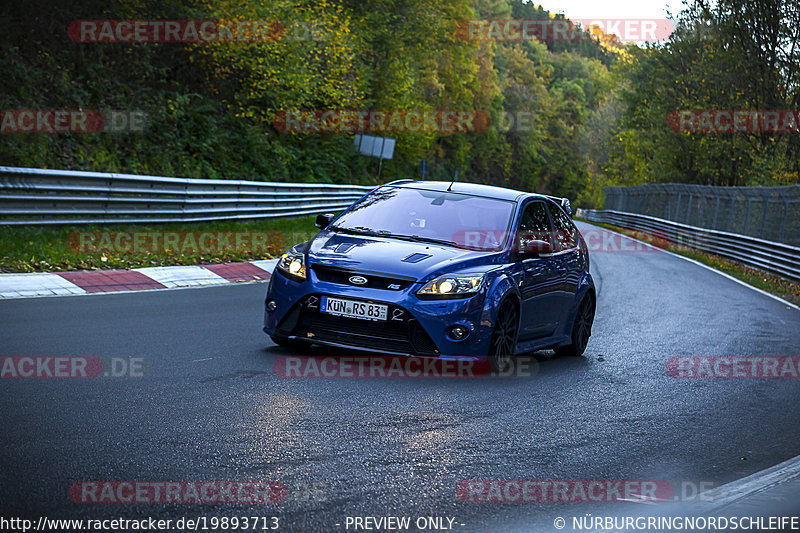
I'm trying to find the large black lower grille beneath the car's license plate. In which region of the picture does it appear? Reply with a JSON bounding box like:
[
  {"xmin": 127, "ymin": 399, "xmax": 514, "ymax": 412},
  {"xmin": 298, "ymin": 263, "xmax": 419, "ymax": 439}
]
[{"xmin": 290, "ymin": 295, "xmax": 439, "ymax": 356}]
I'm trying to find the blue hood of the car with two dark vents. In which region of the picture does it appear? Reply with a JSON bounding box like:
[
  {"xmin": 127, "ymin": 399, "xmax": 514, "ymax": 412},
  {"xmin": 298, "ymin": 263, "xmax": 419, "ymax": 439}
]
[{"xmin": 308, "ymin": 231, "xmax": 500, "ymax": 280}]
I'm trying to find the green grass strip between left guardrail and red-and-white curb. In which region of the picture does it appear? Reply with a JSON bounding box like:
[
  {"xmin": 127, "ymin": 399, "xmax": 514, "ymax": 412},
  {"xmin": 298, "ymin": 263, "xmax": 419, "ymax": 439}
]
[{"xmin": 0, "ymin": 216, "xmax": 318, "ymax": 272}]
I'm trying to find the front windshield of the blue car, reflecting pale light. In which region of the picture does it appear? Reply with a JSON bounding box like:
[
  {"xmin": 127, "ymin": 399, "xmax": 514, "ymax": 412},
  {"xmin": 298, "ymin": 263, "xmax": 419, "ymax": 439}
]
[{"xmin": 332, "ymin": 187, "xmax": 516, "ymax": 251}]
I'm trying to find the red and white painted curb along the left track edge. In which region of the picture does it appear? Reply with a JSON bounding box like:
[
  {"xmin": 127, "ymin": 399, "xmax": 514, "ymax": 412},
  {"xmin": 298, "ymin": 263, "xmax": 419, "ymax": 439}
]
[{"xmin": 0, "ymin": 259, "xmax": 277, "ymax": 299}]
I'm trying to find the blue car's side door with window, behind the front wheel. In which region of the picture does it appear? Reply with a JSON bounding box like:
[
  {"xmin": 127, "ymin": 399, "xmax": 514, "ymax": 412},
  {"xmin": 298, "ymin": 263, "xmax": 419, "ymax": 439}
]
[{"xmin": 516, "ymin": 200, "xmax": 559, "ymax": 341}]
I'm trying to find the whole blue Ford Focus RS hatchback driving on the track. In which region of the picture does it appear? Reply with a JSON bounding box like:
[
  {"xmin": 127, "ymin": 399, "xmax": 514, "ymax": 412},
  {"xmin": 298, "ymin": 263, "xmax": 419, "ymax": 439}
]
[{"xmin": 264, "ymin": 180, "xmax": 596, "ymax": 370}]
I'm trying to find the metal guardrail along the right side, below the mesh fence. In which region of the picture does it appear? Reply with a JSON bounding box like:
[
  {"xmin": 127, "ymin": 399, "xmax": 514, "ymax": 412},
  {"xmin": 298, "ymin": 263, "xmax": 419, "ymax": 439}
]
[{"xmin": 576, "ymin": 209, "xmax": 800, "ymax": 281}]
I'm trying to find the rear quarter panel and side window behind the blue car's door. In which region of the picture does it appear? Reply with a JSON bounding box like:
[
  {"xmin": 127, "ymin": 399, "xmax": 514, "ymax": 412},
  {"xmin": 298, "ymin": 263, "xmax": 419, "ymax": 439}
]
[{"xmin": 547, "ymin": 203, "xmax": 583, "ymax": 324}]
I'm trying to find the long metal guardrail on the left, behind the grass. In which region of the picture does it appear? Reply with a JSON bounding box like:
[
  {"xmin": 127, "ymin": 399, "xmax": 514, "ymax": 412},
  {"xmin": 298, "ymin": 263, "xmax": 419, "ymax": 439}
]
[{"xmin": 0, "ymin": 166, "xmax": 373, "ymax": 225}]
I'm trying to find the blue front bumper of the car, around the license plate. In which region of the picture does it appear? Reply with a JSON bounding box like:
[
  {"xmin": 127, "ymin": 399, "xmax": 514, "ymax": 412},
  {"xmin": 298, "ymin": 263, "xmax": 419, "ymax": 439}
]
[{"xmin": 264, "ymin": 270, "xmax": 496, "ymax": 360}]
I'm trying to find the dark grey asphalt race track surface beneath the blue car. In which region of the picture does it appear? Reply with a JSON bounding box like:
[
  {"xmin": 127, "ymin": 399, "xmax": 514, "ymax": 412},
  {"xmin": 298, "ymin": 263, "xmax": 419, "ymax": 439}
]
[{"xmin": 0, "ymin": 218, "xmax": 800, "ymax": 531}]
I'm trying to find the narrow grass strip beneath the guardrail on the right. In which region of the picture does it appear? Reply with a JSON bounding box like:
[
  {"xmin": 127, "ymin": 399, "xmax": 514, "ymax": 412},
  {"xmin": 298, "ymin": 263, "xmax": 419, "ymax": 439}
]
[{"xmin": 576, "ymin": 217, "xmax": 800, "ymax": 304}]
